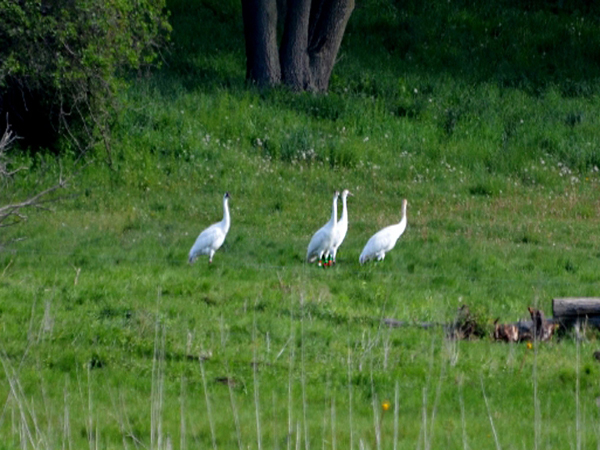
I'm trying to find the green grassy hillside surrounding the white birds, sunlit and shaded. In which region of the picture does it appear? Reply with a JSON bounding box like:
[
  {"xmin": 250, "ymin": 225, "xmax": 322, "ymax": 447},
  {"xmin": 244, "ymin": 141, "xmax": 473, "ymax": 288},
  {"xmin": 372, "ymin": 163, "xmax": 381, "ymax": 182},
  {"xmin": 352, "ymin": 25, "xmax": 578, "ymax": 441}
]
[{"xmin": 0, "ymin": 1, "xmax": 600, "ymax": 450}]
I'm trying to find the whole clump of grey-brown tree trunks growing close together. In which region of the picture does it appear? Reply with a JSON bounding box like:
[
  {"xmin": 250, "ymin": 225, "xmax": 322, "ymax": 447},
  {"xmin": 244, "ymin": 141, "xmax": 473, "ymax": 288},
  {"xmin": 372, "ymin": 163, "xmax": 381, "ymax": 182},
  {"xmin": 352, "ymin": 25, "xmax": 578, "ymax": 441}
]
[{"xmin": 242, "ymin": 0, "xmax": 355, "ymax": 92}]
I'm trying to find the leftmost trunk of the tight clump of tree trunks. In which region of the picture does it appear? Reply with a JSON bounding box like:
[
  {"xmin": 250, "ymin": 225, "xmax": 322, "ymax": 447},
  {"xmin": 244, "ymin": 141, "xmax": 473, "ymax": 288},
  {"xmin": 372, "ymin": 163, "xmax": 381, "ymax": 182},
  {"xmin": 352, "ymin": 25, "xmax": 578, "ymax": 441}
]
[{"xmin": 242, "ymin": 0, "xmax": 281, "ymax": 86}]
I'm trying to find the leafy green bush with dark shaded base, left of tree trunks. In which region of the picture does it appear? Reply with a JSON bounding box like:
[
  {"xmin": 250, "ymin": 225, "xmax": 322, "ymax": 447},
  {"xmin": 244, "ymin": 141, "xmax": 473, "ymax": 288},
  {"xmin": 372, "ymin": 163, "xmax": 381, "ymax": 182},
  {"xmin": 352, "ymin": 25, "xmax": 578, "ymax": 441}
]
[{"xmin": 0, "ymin": 0, "xmax": 170, "ymax": 158}]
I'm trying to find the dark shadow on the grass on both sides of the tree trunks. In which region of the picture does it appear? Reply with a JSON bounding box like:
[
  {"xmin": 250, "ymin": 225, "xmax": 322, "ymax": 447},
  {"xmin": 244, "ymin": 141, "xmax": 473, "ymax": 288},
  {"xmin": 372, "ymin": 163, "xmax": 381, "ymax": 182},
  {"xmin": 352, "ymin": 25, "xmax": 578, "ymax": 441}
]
[{"xmin": 165, "ymin": 0, "xmax": 600, "ymax": 96}]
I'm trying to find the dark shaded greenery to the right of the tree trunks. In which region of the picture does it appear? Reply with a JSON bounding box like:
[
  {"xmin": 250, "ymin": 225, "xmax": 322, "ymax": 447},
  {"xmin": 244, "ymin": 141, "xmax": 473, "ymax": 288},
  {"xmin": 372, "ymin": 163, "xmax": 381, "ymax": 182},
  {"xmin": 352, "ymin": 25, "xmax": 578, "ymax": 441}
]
[{"xmin": 342, "ymin": 0, "xmax": 600, "ymax": 92}]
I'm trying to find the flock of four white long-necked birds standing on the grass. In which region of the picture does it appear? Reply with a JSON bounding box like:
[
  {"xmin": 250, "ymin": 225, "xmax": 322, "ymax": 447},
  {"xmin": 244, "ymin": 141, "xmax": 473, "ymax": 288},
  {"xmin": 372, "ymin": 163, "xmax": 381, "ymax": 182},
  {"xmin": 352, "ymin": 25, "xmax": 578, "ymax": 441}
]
[{"xmin": 188, "ymin": 189, "xmax": 408, "ymax": 265}]
